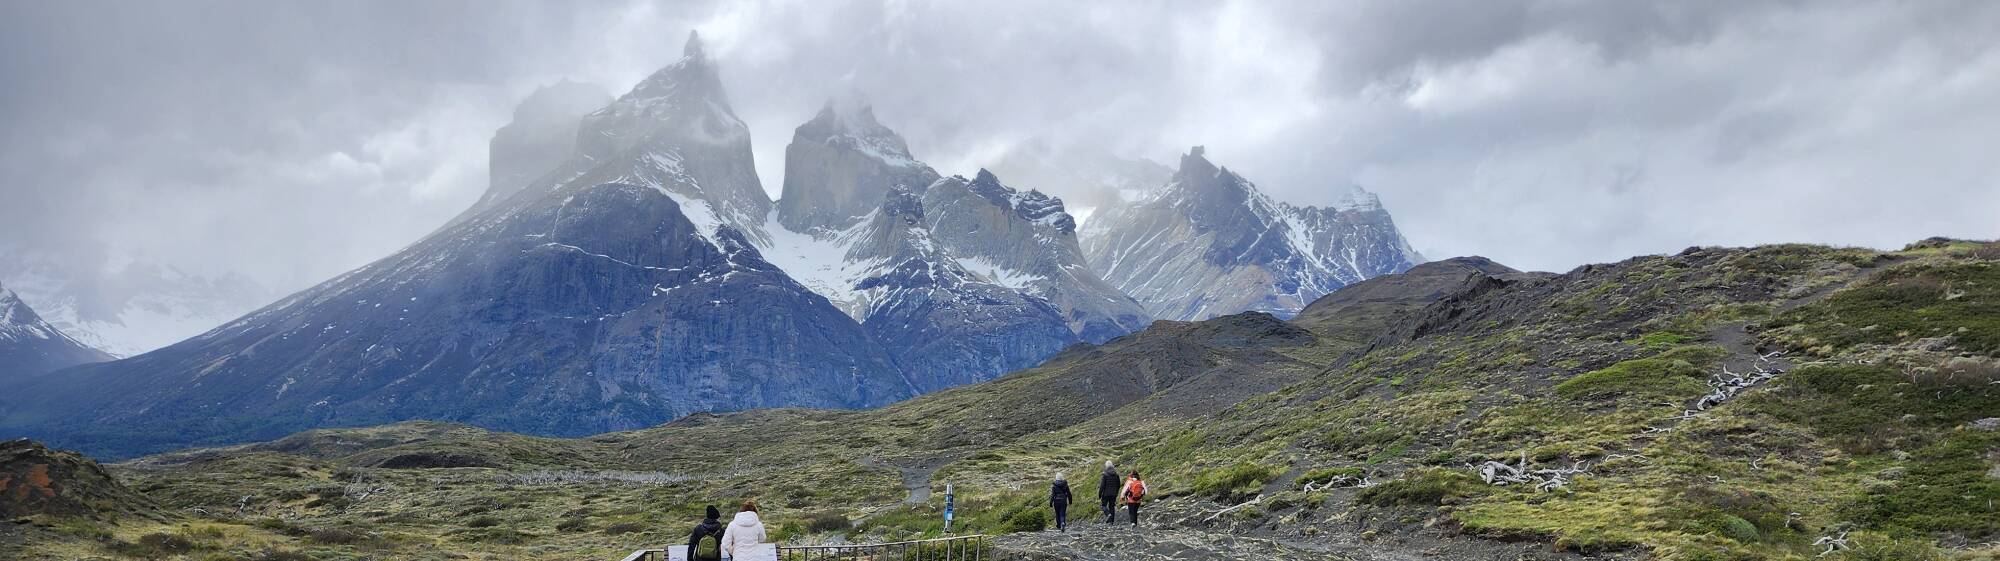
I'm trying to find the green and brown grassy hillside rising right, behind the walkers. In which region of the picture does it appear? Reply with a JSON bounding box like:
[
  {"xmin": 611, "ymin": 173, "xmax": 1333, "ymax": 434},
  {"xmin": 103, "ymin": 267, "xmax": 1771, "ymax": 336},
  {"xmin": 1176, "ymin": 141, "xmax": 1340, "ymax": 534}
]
[{"xmin": 16, "ymin": 240, "xmax": 2000, "ymax": 559}]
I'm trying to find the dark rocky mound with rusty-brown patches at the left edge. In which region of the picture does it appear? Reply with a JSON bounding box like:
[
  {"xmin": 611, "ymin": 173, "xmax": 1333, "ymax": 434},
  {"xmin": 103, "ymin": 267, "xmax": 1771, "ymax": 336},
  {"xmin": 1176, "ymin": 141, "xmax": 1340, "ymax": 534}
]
[{"xmin": 0, "ymin": 439, "xmax": 158, "ymax": 519}]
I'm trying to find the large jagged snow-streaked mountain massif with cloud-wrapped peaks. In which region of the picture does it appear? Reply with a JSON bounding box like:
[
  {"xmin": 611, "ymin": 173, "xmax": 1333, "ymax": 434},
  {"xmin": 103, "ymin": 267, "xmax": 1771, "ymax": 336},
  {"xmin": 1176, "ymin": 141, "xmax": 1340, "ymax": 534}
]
[{"xmin": 0, "ymin": 36, "xmax": 1420, "ymax": 457}]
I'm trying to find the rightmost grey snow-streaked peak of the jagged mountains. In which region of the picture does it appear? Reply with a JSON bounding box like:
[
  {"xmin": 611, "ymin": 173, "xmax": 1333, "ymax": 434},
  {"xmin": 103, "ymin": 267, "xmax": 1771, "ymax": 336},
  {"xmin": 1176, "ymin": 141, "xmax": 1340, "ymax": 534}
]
[{"xmin": 1086, "ymin": 146, "xmax": 1424, "ymax": 319}]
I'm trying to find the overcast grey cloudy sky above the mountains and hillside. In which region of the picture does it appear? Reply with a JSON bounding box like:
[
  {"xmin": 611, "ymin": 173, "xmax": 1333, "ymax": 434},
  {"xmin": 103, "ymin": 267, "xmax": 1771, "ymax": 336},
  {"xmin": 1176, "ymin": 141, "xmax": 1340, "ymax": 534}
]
[{"xmin": 0, "ymin": 0, "xmax": 2000, "ymax": 350}]
